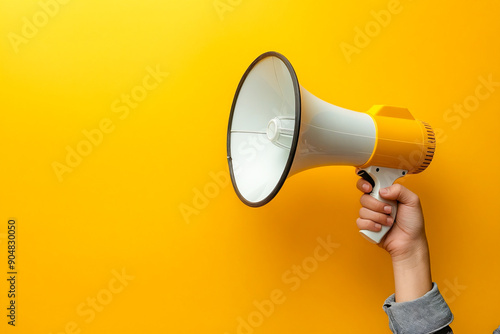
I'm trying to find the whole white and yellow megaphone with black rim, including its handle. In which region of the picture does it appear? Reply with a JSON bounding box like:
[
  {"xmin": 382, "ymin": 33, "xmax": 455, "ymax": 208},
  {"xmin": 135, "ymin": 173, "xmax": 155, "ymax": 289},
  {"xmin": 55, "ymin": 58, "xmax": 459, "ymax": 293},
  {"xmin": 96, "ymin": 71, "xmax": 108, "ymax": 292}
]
[{"xmin": 227, "ymin": 52, "xmax": 436, "ymax": 243}]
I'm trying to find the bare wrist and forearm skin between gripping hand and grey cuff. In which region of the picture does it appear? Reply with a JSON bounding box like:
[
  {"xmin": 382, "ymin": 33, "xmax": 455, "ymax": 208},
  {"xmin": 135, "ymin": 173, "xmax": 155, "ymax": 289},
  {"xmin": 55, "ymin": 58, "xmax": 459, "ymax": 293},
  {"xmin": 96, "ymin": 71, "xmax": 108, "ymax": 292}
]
[{"xmin": 392, "ymin": 237, "xmax": 432, "ymax": 303}]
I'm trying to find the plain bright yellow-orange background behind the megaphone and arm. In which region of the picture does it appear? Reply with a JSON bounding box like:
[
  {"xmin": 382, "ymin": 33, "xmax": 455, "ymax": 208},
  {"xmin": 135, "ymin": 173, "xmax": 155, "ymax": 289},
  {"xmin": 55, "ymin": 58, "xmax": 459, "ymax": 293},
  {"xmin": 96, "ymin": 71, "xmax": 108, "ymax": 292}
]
[{"xmin": 0, "ymin": 0, "xmax": 500, "ymax": 334}]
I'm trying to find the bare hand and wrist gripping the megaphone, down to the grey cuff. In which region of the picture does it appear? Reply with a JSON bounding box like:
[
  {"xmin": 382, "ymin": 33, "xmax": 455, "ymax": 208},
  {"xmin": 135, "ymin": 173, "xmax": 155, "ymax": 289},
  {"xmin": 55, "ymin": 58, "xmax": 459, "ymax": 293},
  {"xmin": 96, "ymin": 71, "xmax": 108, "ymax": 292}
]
[{"xmin": 356, "ymin": 174, "xmax": 432, "ymax": 302}]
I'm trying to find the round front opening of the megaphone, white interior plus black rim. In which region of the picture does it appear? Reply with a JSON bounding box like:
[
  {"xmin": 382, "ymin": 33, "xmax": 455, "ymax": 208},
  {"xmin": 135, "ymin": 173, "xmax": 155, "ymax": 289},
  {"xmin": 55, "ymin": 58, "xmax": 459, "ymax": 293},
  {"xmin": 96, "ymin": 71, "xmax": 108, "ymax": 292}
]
[{"xmin": 227, "ymin": 52, "xmax": 301, "ymax": 206}]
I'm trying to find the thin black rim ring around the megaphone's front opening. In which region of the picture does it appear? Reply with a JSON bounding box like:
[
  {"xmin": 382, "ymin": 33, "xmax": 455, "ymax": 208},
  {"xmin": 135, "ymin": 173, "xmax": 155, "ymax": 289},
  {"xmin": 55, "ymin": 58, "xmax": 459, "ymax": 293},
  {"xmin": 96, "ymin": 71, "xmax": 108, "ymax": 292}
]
[{"xmin": 227, "ymin": 51, "xmax": 301, "ymax": 207}]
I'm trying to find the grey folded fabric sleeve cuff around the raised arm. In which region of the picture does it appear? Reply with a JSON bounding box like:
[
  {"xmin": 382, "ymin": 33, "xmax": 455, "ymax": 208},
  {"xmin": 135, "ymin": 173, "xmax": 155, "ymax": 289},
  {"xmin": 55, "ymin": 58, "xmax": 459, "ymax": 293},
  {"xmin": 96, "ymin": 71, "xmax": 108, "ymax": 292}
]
[{"xmin": 384, "ymin": 283, "xmax": 453, "ymax": 334}]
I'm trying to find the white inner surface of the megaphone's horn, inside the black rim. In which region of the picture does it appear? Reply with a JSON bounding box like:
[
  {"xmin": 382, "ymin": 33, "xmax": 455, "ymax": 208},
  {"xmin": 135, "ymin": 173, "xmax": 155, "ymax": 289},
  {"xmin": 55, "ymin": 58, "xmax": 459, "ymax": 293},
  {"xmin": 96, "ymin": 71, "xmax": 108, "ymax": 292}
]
[{"xmin": 231, "ymin": 57, "xmax": 295, "ymax": 203}]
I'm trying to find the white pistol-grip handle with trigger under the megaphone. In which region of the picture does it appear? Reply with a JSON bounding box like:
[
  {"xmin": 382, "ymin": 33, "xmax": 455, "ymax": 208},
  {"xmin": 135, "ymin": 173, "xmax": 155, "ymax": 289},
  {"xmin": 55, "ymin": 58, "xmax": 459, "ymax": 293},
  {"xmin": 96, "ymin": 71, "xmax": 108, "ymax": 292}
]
[{"xmin": 358, "ymin": 166, "xmax": 408, "ymax": 244}]
